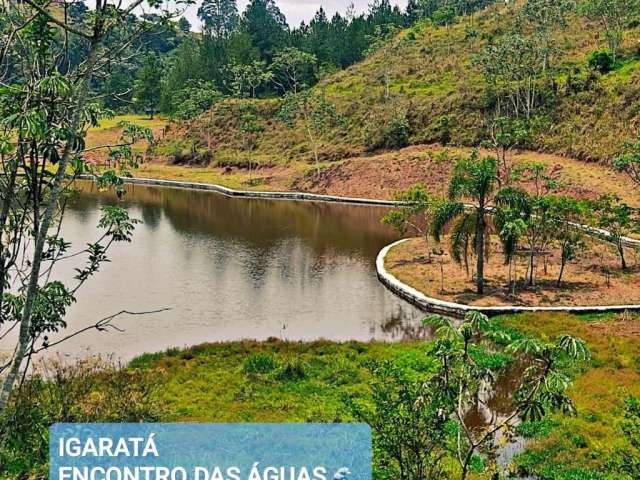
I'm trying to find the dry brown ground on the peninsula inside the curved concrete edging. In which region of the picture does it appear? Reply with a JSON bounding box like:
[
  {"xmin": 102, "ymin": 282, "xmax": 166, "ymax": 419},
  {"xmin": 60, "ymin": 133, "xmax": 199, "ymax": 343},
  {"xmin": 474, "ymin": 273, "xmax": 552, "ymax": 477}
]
[{"xmin": 385, "ymin": 238, "xmax": 640, "ymax": 306}]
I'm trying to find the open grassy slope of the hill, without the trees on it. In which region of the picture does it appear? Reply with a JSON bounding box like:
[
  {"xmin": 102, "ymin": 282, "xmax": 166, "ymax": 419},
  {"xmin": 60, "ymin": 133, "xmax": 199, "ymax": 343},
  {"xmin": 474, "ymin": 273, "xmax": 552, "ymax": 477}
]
[{"xmin": 156, "ymin": 3, "xmax": 640, "ymax": 169}]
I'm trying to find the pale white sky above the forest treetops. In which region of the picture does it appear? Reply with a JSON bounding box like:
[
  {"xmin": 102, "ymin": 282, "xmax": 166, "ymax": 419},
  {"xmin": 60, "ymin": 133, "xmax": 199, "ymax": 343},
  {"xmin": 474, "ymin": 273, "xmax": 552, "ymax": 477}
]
[{"xmin": 181, "ymin": 0, "xmax": 407, "ymax": 30}]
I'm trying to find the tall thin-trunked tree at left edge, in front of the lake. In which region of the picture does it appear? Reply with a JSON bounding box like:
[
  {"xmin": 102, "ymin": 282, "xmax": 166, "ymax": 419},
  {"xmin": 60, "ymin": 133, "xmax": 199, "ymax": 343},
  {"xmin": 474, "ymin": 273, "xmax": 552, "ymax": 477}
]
[{"xmin": 0, "ymin": 0, "xmax": 184, "ymax": 411}]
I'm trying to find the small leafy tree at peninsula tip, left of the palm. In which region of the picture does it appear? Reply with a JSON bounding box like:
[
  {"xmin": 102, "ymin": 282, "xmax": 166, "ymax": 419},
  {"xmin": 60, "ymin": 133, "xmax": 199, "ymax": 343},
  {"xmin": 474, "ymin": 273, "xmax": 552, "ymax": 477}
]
[{"xmin": 382, "ymin": 183, "xmax": 439, "ymax": 258}]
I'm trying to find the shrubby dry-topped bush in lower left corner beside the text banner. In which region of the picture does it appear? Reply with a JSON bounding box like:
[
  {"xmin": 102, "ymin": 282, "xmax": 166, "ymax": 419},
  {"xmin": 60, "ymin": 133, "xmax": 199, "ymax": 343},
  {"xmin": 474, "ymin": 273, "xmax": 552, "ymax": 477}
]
[{"xmin": 0, "ymin": 359, "xmax": 161, "ymax": 478}]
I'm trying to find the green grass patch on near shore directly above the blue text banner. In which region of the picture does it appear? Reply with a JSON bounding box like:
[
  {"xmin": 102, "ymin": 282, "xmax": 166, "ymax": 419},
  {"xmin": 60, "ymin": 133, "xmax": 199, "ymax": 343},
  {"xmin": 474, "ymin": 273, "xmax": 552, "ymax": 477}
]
[{"xmin": 131, "ymin": 340, "xmax": 434, "ymax": 422}]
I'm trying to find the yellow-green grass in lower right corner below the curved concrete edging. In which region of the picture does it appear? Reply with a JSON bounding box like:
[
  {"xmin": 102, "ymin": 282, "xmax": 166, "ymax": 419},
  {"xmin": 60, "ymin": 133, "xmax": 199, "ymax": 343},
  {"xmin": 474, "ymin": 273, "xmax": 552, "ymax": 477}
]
[{"xmin": 498, "ymin": 314, "xmax": 640, "ymax": 480}]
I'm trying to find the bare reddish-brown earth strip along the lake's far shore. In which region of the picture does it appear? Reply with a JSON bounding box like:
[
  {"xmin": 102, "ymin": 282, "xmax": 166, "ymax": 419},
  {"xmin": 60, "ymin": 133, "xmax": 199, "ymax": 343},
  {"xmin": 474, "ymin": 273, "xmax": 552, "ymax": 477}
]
[{"xmin": 102, "ymin": 140, "xmax": 640, "ymax": 207}]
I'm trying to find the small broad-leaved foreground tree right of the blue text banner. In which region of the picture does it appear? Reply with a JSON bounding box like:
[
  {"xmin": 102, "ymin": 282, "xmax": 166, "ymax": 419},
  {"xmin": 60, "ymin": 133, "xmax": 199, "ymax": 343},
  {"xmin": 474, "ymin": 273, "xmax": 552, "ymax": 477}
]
[{"xmin": 426, "ymin": 312, "xmax": 590, "ymax": 480}]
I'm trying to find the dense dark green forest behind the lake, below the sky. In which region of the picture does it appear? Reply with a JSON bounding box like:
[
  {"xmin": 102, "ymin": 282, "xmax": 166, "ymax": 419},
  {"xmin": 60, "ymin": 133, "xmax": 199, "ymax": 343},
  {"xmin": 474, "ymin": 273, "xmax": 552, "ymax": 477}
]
[{"xmin": 64, "ymin": 0, "xmax": 491, "ymax": 119}]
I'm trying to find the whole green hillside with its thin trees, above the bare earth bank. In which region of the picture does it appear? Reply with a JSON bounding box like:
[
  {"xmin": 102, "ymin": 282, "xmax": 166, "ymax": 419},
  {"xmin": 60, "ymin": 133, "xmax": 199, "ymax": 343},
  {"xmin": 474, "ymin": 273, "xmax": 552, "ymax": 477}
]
[{"xmin": 159, "ymin": 1, "xmax": 640, "ymax": 171}]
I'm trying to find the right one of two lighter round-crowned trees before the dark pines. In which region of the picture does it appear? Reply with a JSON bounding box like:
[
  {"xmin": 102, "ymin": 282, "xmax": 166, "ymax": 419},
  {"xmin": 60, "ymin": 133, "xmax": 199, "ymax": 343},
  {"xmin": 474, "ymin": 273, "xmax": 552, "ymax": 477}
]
[{"xmin": 271, "ymin": 47, "xmax": 317, "ymax": 95}]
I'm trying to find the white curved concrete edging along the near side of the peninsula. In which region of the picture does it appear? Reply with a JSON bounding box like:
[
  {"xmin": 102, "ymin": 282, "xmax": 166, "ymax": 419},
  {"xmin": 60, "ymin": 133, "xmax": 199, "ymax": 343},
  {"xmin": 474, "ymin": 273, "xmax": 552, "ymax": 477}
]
[{"xmin": 376, "ymin": 239, "xmax": 640, "ymax": 317}]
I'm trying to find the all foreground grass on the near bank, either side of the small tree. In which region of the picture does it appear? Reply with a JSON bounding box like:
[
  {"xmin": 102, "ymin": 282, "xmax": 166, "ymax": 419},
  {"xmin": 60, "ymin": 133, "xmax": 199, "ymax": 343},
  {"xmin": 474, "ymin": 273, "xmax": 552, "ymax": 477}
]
[{"xmin": 131, "ymin": 314, "xmax": 640, "ymax": 480}]
